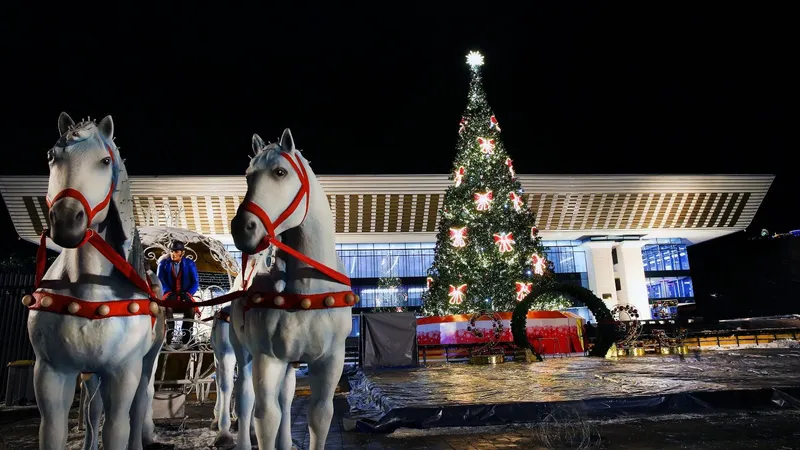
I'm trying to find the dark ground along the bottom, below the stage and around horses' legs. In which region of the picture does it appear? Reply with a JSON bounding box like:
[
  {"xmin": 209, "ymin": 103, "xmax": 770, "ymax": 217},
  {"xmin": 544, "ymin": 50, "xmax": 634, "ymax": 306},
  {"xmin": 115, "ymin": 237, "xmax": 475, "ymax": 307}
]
[{"xmin": 0, "ymin": 394, "xmax": 800, "ymax": 450}]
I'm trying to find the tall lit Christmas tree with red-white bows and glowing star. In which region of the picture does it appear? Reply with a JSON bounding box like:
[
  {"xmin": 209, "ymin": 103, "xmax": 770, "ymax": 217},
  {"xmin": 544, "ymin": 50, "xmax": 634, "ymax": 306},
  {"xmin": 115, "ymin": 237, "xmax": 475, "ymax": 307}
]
[{"xmin": 422, "ymin": 52, "xmax": 547, "ymax": 315}]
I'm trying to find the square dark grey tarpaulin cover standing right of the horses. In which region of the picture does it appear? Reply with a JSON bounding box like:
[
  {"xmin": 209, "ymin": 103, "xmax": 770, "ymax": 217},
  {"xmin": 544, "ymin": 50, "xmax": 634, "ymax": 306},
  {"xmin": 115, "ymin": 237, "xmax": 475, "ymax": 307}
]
[{"xmin": 361, "ymin": 312, "xmax": 419, "ymax": 368}]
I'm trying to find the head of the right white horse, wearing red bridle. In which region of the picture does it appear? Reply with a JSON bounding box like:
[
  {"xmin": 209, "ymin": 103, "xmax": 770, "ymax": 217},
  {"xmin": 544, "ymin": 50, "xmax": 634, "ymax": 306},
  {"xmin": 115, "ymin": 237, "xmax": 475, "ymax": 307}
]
[{"xmin": 231, "ymin": 128, "xmax": 311, "ymax": 254}]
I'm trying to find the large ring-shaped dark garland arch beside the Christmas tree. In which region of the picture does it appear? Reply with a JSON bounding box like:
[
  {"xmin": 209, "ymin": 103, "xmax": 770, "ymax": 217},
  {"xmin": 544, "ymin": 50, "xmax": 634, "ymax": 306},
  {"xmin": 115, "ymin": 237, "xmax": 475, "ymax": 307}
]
[{"xmin": 511, "ymin": 283, "xmax": 616, "ymax": 361}]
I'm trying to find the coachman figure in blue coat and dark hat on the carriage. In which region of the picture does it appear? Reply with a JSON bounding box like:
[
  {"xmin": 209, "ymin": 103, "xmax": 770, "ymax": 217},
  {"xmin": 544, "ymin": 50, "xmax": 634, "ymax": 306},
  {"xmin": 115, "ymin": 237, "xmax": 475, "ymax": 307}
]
[{"xmin": 158, "ymin": 241, "xmax": 200, "ymax": 345}]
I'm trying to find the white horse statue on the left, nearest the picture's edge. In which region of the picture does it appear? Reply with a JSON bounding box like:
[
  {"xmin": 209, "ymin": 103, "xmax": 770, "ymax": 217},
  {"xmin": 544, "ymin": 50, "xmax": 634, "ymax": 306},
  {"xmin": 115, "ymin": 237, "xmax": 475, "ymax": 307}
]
[{"xmin": 23, "ymin": 113, "xmax": 165, "ymax": 450}]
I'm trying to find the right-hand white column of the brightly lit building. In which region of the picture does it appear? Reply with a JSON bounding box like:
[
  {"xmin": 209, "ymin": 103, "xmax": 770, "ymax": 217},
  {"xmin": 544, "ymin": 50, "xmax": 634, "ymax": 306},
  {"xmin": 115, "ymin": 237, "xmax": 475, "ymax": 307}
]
[{"xmin": 616, "ymin": 241, "xmax": 652, "ymax": 320}]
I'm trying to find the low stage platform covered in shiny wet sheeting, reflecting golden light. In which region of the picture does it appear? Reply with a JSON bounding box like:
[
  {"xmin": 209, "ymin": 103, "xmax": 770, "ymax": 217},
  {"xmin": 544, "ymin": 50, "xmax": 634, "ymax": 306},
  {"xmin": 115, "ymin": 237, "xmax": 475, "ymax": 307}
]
[{"xmin": 348, "ymin": 348, "xmax": 800, "ymax": 433}]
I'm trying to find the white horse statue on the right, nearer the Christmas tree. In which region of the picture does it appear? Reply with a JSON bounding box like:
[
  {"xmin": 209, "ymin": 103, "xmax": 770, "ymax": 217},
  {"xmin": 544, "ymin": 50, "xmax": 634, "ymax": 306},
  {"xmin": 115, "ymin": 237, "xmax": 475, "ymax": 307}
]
[{"xmin": 231, "ymin": 129, "xmax": 358, "ymax": 450}]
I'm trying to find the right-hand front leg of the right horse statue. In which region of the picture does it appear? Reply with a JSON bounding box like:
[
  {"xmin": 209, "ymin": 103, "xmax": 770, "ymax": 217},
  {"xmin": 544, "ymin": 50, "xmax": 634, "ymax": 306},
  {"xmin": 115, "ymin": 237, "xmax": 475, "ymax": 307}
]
[{"xmin": 308, "ymin": 345, "xmax": 344, "ymax": 450}]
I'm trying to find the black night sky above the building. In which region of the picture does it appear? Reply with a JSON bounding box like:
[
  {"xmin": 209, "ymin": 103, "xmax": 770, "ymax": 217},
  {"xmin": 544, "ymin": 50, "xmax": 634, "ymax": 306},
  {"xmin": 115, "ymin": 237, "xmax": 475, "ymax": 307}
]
[{"xmin": 0, "ymin": 2, "xmax": 800, "ymax": 254}]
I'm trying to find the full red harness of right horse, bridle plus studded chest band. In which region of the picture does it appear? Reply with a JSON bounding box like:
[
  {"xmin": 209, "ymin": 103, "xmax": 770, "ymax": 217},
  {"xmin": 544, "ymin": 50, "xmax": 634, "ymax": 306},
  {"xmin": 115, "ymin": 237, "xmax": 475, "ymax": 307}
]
[{"xmin": 242, "ymin": 152, "xmax": 358, "ymax": 311}]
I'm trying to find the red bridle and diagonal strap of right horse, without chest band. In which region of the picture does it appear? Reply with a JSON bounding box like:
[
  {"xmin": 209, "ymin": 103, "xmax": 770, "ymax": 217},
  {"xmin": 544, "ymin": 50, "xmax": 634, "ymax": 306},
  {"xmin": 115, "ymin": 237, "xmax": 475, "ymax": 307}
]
[{"xmin": 242, "ymin": 152, "xmax": 350, "ymax": 288}]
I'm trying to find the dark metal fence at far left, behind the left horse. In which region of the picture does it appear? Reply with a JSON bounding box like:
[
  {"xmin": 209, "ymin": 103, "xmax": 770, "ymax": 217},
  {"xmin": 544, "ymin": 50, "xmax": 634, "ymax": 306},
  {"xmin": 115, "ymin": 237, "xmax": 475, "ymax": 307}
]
[{"xmin": 0, "ymin": 270, "xmax": 35, "ymax": 397}]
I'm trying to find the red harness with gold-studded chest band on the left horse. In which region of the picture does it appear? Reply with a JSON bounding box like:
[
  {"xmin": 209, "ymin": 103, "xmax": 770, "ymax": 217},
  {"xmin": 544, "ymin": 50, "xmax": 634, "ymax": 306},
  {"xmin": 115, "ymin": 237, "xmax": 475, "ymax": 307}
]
[{"xmin": 22, "ymin": 144, "xmax": 158, "ymax": 325}]
